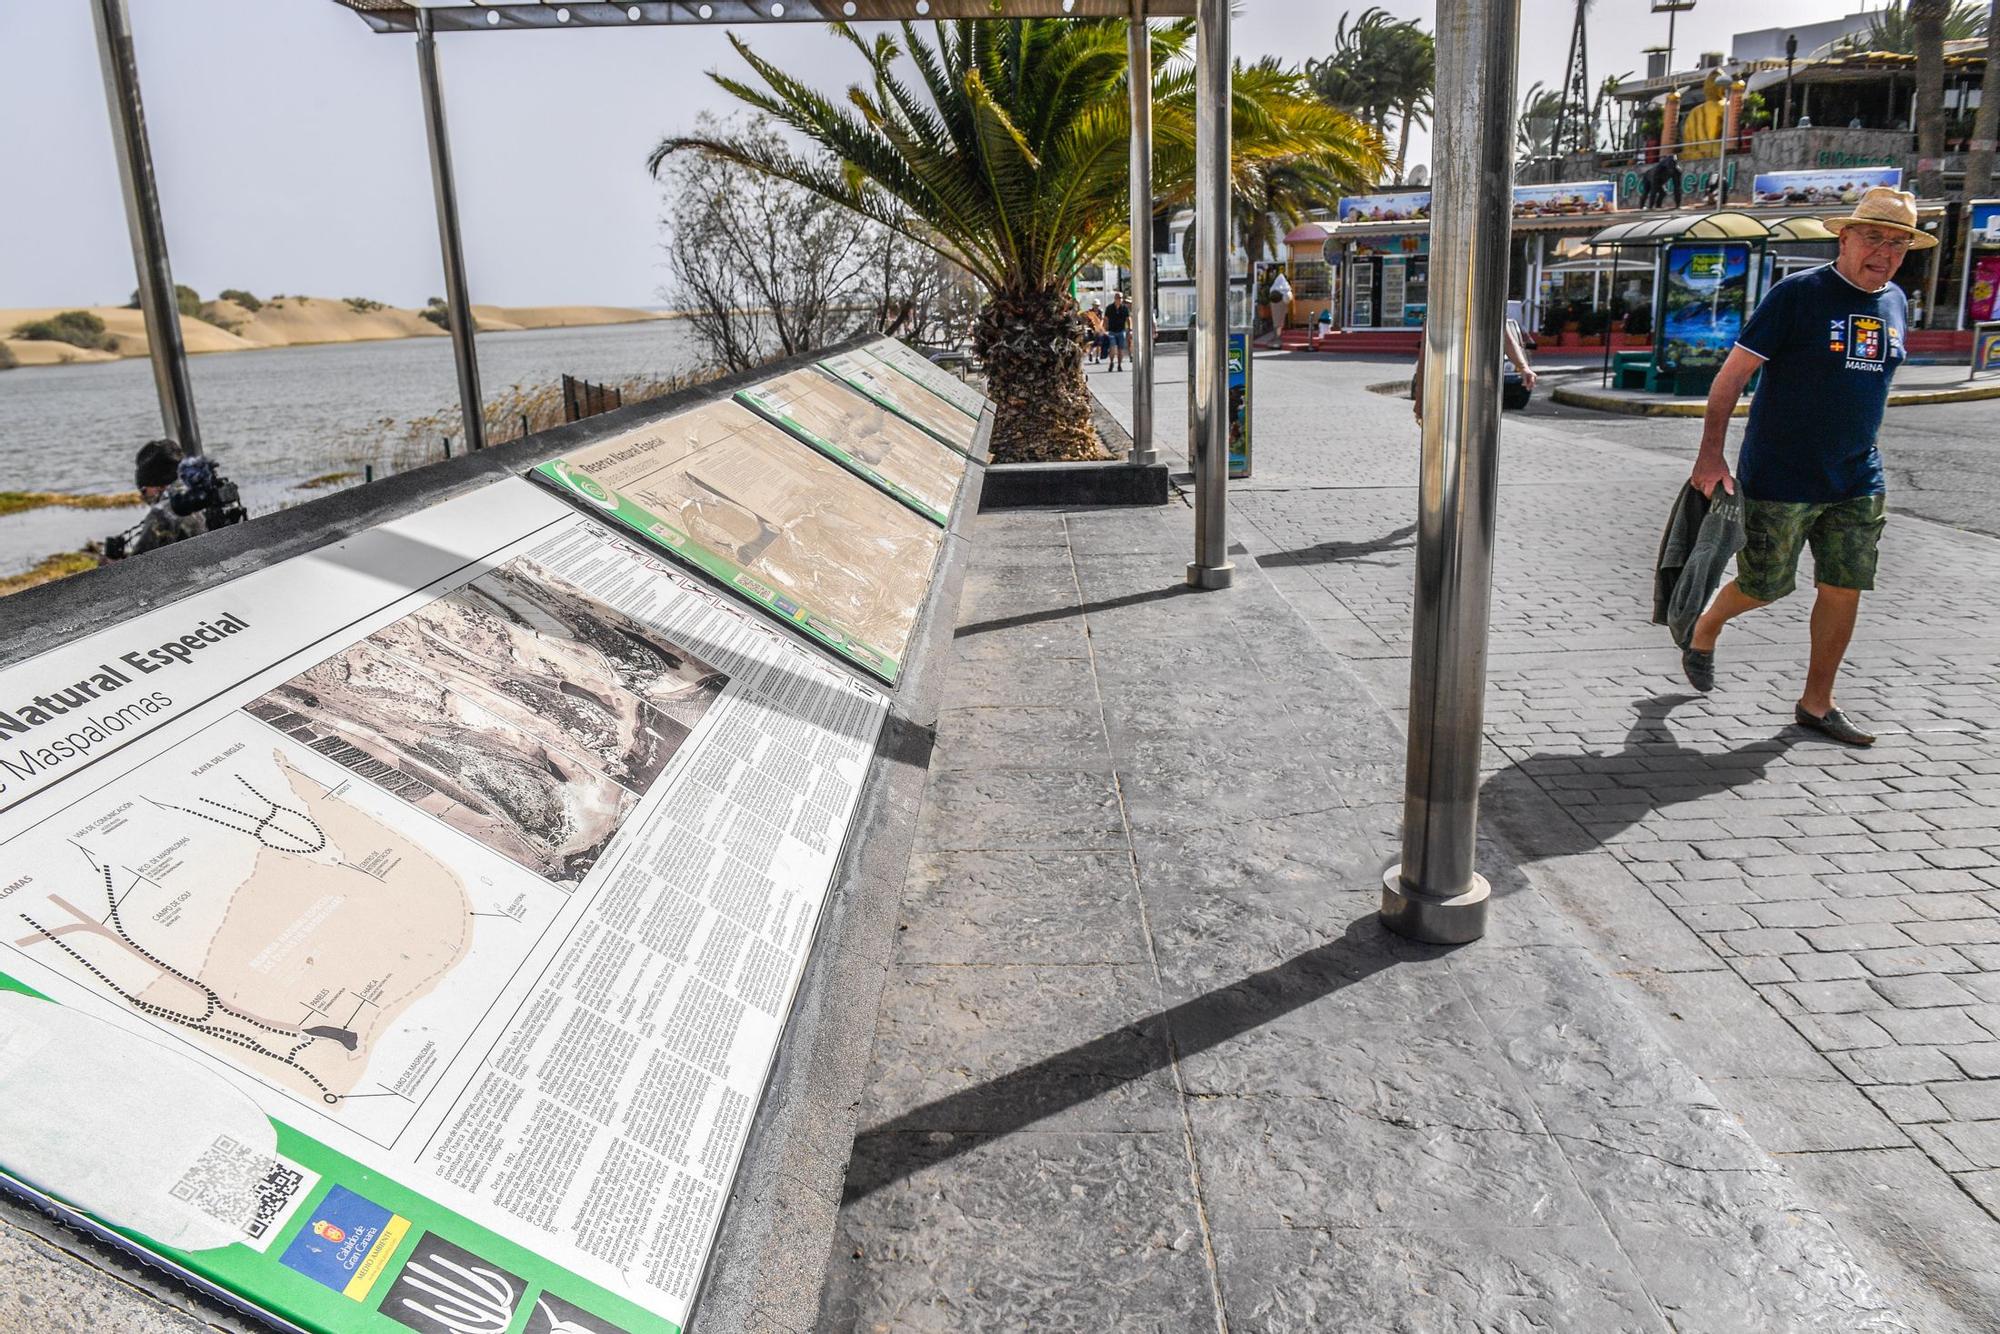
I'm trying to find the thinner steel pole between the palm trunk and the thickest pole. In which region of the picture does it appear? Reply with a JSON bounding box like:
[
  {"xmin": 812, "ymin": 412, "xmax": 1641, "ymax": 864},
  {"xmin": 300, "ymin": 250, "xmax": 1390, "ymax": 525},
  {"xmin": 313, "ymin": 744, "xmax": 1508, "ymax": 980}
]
[{"xmin": 1188, "ymin": 0, "xmax": 1236, "ymax": 588}]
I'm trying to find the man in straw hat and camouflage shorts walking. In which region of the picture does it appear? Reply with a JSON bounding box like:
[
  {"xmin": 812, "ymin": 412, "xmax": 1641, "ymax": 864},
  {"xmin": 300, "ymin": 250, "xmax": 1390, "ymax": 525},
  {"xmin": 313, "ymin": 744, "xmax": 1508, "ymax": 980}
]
[{"xmin": 1680, "ymin": 186, "xmax": 1938, "ymax": 746}]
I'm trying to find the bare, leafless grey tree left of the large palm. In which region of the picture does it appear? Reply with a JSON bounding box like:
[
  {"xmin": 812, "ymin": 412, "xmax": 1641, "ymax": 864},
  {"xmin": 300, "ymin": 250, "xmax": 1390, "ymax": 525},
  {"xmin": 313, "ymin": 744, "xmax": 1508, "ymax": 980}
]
[{"xmin": 658, "ymin": 114, "xmax": 976, "ymax": 370}]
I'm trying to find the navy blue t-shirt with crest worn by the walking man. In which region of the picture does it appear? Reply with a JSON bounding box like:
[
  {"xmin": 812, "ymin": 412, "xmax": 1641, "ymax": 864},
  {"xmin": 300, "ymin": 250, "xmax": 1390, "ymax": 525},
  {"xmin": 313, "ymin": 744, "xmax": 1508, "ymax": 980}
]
[{"xmin": 1736, "ymin": 264, "xmax": 1910, "ymax": 502}]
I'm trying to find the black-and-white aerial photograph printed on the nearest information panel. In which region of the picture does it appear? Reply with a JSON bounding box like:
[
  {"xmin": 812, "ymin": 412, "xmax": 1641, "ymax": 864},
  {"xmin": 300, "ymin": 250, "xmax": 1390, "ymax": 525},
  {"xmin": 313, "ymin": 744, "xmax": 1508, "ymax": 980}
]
[{"xmin": 246, "ymin": 558, "xmax": 728, "ymax": 884}]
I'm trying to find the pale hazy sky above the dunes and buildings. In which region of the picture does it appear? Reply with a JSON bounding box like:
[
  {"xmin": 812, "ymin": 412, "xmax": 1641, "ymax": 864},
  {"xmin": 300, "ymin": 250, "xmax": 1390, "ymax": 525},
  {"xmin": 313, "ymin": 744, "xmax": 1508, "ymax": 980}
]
[{"xmin": 0, "ymin": 0, "xmax": 1860, "ymax": 306}]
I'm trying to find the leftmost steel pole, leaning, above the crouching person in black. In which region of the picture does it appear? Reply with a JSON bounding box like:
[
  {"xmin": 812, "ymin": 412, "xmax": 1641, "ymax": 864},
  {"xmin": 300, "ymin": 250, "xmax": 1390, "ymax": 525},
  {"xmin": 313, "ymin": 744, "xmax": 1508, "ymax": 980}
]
[{"xmin": 90, "ymin": 0, "xmax": 202, "ymax": 454}]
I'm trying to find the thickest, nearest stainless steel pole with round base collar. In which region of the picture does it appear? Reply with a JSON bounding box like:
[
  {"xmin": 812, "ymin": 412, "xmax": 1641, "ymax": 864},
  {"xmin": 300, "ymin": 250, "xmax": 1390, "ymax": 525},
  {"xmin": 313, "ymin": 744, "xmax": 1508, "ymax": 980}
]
[{"xmin": 1382, "ymin": 0, "xmax": 1520, "ymax": 944}]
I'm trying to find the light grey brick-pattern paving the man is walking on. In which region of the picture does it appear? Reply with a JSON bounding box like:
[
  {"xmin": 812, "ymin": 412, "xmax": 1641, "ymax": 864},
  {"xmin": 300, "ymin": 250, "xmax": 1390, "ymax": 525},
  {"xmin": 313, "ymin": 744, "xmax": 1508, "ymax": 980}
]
[{"xmin": 1106, "ymin": 358, "xmax": 2000, "ymax": 1330}]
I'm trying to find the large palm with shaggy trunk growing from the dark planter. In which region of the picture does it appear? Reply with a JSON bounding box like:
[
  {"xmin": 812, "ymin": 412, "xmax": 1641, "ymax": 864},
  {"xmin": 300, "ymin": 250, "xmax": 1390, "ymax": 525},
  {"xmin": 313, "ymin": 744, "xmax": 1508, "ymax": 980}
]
[{"xmin": 664, "ymin": 18, "xmax": 1382, "ymax": 460}]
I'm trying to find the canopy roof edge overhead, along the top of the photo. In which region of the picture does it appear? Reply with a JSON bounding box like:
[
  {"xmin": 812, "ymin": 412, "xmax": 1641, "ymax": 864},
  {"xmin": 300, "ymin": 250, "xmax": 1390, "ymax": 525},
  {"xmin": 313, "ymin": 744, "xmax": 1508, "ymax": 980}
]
[{"xmin": 334, "ymin": 0, "xmax": 1194, "ymax": 32}]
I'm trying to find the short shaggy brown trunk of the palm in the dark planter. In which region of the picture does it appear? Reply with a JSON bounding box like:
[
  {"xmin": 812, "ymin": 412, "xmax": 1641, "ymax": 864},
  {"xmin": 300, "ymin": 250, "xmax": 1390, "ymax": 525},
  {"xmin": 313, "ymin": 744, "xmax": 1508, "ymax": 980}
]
[{"xmin": 972, "ymin": 288, "xmax": 1104, "ymax": 464}]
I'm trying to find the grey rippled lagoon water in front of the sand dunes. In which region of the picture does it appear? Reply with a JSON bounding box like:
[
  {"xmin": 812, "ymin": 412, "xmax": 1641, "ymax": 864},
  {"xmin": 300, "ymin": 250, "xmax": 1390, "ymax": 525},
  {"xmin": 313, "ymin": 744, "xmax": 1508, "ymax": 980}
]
[{"xmin": 0, "ymin": 320, "xmax": 702, "ymax": 574}]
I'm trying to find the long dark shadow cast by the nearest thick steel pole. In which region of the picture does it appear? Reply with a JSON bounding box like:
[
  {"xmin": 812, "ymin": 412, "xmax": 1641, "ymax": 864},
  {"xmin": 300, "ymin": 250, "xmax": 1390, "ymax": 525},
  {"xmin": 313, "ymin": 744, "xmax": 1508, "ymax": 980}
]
[{"xmin": 842, "ymin": 912, "xmax": 1450, "ymax": 1204}]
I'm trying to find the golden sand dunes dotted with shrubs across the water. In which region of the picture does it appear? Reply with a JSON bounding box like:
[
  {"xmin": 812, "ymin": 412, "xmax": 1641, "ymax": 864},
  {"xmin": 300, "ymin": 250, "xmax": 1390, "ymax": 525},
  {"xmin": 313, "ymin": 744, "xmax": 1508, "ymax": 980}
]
[{"xmin": 0, "ymin": 296, "xmax": 674, "ymax": 366}]
